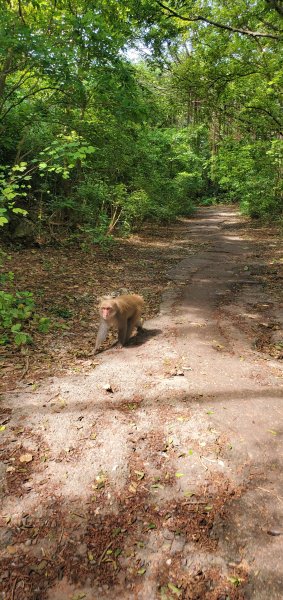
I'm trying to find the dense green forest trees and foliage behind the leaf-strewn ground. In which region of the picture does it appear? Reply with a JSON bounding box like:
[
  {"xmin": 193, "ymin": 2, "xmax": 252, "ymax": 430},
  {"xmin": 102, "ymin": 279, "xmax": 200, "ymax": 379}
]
[{"xmin": 0, "ymin": 0, "xmax": 283, "ymax": 237}]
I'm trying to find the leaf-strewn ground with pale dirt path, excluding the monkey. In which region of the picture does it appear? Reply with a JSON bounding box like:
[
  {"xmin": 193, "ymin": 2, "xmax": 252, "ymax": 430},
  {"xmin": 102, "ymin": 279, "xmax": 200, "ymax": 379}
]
[{"xmin": 0, "ymin": 206, "xmax": 283, "ymax": 600}]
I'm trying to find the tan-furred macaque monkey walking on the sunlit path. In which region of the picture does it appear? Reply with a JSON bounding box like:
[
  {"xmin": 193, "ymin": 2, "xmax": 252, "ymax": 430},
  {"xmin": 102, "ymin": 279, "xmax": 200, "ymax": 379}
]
[{"xmin": 94, "ymin": 294, "xmax": 144, "ymax": 352}]
